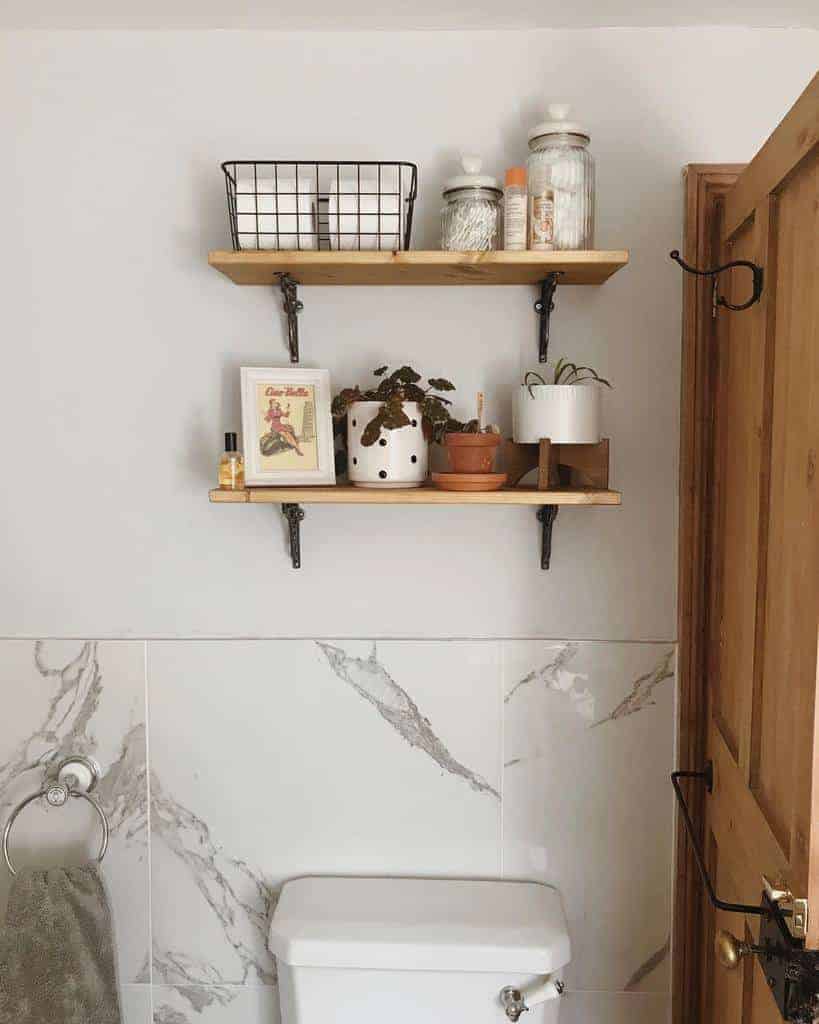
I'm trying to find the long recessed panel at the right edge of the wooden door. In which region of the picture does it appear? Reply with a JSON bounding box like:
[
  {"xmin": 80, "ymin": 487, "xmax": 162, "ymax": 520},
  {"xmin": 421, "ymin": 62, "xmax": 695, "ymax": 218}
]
[{"xmin": 751, "ymin": 146, "xmax": 819, "ymax": 901}]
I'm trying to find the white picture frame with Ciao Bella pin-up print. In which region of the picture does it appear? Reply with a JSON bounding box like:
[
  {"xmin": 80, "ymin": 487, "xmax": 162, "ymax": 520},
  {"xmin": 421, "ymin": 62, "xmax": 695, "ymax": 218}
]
[{"xmin": 241, "ymin": 367, "xmax": 336, "ymax": 486}]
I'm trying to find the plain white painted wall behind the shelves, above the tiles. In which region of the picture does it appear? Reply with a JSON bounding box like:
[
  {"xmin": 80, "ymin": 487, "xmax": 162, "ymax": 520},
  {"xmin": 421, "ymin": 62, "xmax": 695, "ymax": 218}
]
[{"xmin": 0, "ymin": 29, "xmax": 819, "ymax": 640}]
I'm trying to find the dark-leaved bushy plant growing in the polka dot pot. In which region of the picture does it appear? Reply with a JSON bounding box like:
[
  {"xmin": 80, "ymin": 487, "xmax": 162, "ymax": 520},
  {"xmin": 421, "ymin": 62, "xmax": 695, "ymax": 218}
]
[{"xmin": 332, "ymin": 367, "xmax": 478, "ymax": 447}]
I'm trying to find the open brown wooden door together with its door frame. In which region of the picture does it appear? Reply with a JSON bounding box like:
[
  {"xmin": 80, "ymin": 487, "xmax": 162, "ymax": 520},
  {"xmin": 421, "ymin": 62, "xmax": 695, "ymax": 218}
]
[{"xmin": 675, "ymin": 76, "xmax": 819, "ymax": 1024}]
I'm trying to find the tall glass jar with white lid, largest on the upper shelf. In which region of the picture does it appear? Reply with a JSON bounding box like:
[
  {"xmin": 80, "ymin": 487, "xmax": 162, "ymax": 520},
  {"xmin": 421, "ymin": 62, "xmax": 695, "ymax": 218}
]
[{"xmin": 527, "ymin": 103, "xmax": 595, "ymax": 250}]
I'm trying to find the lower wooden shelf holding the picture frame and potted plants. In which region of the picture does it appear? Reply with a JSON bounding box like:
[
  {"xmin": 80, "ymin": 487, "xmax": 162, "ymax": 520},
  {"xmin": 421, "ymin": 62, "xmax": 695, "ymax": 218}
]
[{"xmin": 210, "ymin": 484, "xmax": 620, "ymax": 506}]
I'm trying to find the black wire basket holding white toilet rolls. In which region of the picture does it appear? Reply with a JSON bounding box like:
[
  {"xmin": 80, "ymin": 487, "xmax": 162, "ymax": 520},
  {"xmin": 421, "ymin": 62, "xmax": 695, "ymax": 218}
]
[{"xmin": 222, "ymin": 160, "xmax": 418, "ymax": 252}]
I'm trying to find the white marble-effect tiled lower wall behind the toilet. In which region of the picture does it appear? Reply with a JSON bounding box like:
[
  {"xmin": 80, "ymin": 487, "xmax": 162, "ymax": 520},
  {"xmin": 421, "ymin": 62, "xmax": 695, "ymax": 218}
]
[{"xmin": 0, "ymin": 640, "xmax": 675, "ymax": 1024}]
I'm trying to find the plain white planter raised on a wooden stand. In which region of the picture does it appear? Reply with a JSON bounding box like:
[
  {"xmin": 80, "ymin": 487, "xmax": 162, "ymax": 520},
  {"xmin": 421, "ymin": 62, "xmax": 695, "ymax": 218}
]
[{"xmin": 513, "ymin": 384, "xmax": 600, "ymax": 444}]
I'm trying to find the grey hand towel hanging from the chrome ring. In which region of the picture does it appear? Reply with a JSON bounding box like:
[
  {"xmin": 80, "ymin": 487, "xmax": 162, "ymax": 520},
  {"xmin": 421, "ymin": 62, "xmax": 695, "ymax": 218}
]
[{"xmin": 0, "ymin": 864, "xmax": 121, "ymax": 1024}]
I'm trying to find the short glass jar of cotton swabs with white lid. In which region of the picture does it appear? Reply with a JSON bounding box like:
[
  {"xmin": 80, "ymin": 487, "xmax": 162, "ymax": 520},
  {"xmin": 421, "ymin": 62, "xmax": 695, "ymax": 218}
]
[{"xmin": 441, "ymin": 157, "xmax": 504, "ymax": 252}]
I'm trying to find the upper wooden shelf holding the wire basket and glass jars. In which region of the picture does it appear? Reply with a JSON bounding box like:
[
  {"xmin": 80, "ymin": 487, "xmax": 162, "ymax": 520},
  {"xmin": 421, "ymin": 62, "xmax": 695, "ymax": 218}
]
[{"xmin": 208, "ymin": 250, "xmax": 629, "ymax": 285}]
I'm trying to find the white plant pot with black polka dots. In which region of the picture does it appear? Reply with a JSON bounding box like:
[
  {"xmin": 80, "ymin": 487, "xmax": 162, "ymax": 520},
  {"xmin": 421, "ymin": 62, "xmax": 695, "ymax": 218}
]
[{"xmin": 347, "ymin": 401, "xmax": 429, "ymax": 487}]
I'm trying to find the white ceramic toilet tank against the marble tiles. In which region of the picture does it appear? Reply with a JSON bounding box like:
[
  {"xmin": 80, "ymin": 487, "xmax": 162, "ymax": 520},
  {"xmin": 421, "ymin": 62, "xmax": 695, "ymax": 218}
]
[{"xmin": 270, "ymin": 878, "xmax": 571, "ymax": 1024}]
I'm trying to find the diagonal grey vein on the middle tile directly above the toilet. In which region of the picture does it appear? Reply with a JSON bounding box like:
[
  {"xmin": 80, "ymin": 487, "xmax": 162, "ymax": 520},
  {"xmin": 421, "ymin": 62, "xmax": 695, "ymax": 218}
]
[{"xmin": 316, "ymin": 640, "xmax": 501, "ymax": 800}]
